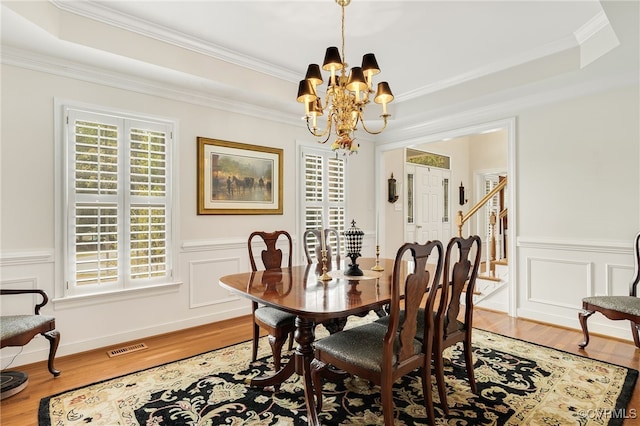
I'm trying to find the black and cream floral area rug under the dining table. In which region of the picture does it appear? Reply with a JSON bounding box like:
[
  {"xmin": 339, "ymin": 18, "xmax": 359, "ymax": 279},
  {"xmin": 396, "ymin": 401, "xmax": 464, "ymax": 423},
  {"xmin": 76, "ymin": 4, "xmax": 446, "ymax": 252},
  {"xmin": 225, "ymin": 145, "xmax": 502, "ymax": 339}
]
[{"xmin": 38, "ymin": 324, "xmax": 638, "ymax": 426}]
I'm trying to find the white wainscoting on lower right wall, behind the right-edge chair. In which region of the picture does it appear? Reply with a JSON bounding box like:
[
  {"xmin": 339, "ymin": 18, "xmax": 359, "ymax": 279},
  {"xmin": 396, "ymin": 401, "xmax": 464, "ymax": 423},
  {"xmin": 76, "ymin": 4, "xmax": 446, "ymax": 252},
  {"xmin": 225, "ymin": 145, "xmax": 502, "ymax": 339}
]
[{"xmin": 515, "ymin": 237, "xmax": 633, "ymax": 345}]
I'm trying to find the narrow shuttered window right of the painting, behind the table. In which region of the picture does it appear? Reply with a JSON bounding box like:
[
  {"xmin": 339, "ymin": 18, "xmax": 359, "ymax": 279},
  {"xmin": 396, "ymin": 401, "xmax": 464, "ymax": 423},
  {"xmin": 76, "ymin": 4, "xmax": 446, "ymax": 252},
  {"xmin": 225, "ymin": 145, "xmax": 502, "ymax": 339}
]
[{"xmin": 302, "ymin": 148, "xmax": 346, "ymax": 262}]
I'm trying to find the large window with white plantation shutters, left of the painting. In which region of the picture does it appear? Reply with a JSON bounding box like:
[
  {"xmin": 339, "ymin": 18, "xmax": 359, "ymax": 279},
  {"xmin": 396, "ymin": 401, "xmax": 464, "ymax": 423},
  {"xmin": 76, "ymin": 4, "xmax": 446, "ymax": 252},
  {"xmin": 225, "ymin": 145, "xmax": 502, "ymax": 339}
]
[{"xmin": 64, "ymin": 107, "xmax": 173, "ymax": 295}]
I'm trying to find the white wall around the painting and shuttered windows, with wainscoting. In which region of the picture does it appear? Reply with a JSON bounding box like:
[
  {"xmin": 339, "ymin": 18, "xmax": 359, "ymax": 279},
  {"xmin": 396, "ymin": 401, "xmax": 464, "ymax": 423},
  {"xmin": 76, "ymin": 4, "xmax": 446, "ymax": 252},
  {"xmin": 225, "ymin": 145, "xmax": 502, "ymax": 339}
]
[{"xmin": 0, "ymin": 65, "xmax": 375, "ymax": 368}]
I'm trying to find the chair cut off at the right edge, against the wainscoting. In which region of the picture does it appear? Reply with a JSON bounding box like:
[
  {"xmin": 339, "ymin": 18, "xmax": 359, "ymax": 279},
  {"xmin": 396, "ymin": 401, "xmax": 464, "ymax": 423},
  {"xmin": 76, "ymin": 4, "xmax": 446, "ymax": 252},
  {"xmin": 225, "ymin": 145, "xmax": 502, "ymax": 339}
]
[{"xmin": 578, "ymin": 233, "xmax": 640, "ymax": 349}]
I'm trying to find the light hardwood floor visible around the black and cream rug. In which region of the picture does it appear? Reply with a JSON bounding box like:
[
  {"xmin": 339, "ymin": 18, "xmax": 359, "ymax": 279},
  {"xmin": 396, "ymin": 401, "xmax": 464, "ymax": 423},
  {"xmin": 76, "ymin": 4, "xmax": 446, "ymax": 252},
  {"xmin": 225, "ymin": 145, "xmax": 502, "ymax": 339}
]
[{"xmin": 0, "ymin": 309, "xmax": 640, "ymax": 426}]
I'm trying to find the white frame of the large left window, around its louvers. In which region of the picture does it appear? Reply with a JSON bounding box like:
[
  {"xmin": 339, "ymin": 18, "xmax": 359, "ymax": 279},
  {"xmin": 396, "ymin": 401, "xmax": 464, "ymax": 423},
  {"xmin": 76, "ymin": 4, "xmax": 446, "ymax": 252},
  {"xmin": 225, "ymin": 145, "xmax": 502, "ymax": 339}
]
[{"xmin": 54, "ymin": 99, "xmax": 180, "ymax": 301}]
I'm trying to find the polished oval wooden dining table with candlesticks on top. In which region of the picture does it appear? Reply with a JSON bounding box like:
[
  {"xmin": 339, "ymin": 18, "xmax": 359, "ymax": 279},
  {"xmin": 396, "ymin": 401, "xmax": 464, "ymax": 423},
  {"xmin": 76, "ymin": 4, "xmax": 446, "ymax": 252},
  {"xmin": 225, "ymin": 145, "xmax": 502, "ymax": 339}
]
[{"xmin": 220, "ymin": 258, "xmax": 404, "ymax": 425}]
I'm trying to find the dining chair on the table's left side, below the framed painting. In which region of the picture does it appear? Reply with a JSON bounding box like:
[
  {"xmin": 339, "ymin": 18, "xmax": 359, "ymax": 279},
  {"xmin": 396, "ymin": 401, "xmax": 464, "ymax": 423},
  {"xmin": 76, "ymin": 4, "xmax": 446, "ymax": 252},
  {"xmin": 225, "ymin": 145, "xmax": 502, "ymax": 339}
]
[{"xmin": 248, "ymin": 231, "xmax": 296, "ymax": 371}]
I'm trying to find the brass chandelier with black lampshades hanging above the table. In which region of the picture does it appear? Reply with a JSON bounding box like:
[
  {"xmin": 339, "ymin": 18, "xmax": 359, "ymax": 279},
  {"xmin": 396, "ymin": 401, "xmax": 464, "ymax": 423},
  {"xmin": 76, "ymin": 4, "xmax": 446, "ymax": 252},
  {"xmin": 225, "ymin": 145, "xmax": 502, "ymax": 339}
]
[{"xmin": 298, "ymin": 0, "xmax": 393, "ymax": 155}]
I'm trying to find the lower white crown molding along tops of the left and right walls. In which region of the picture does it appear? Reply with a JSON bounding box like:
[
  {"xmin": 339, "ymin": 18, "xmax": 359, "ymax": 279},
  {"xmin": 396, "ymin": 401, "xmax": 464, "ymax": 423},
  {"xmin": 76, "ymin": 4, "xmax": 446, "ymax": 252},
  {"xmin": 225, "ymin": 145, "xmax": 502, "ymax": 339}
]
[{"xmin": 0, "ymin": 46, "xmax": 638, "ymax": 145}]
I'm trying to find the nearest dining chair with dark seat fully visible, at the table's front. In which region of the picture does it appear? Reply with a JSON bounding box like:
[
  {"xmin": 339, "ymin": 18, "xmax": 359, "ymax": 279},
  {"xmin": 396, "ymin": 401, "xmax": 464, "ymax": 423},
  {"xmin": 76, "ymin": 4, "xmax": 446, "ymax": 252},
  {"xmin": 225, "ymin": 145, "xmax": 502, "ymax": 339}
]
[{"xmin": 311, "ymin": 241, "xmax": 443, "ymax": 425}]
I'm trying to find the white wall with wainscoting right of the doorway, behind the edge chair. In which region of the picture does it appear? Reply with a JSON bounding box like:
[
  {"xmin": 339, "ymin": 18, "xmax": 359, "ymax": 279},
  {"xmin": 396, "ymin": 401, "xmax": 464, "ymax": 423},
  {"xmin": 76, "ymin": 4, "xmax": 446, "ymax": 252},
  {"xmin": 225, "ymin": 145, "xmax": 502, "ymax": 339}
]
[{"xmin": 516, "ymin": 86, "xmax": 640, "ymax": 332}]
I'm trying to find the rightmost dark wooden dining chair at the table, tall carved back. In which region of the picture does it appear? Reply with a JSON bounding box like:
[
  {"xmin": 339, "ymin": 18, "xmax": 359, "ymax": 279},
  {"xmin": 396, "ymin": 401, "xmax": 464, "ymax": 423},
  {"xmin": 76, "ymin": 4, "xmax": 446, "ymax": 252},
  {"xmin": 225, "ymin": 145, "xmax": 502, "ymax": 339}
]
[{"xmin": 433, "ymin": 235, "xmax": 482, "ymax": 414}]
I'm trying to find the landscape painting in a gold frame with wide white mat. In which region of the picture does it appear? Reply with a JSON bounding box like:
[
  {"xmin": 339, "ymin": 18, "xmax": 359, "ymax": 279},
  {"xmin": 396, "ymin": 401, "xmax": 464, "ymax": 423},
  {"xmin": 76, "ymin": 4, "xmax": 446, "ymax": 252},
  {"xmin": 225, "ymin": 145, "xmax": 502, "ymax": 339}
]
[{"xmin": 198, "ymin": 137, "xmax": 282, "ymax": 214}]
